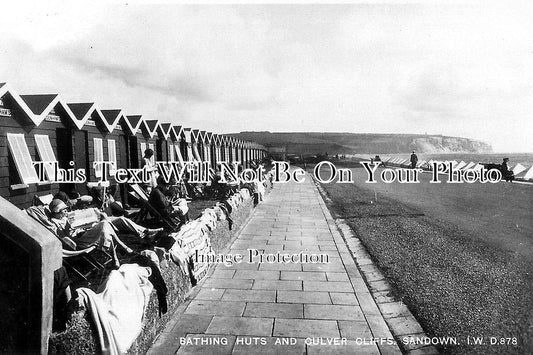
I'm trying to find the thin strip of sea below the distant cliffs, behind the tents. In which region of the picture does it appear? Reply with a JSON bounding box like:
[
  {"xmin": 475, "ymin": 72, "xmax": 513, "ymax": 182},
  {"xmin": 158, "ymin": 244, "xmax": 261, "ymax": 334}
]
[{"xmin": 368, "ymin": 153, "xmax": 533, "ymax": 168}]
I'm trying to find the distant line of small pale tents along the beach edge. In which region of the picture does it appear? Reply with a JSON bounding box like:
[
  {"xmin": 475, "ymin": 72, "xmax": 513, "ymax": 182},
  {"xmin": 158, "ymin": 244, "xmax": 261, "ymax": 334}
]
[{"xmin": 353, "ymin": 154, "xmax": 533, "ymax": 182}]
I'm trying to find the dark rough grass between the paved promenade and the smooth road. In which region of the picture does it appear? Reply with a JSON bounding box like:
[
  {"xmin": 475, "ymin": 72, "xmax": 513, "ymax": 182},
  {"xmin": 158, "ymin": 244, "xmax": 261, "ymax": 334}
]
[{"xmin": 322, "ymin": 168, "xmax": 533, "ymax": 354}]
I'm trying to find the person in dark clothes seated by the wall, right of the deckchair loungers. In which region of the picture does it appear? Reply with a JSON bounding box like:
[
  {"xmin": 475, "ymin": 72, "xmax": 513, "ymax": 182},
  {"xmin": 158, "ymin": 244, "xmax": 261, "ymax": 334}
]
[{"xmin": 148, "ymin": 176, "xmax": 189, "ymax": 224}]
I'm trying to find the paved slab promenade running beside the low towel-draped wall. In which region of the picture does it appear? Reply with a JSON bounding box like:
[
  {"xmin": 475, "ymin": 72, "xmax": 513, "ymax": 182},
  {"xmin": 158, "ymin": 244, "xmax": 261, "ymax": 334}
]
[{"xmin": 149, "ymin": 177, "xmax": 400, "ymax": 354}]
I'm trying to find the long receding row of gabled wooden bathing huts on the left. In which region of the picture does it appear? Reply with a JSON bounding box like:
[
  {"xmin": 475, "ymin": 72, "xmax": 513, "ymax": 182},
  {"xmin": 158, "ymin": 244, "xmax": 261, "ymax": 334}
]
[{"xmin": 0, "ymin": 83, "xmax": 266, "ymax": 208}]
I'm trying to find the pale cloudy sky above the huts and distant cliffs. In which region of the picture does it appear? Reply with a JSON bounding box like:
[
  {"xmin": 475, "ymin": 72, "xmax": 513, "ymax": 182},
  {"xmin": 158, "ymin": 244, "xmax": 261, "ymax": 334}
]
[{"xmin": 0, "ymin": 1, "xmax": 533, "ymax": 152}]
